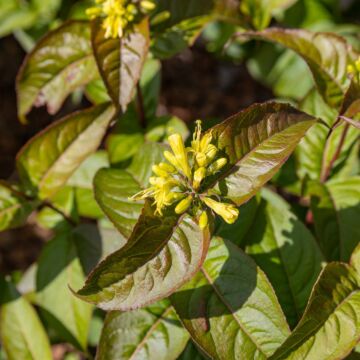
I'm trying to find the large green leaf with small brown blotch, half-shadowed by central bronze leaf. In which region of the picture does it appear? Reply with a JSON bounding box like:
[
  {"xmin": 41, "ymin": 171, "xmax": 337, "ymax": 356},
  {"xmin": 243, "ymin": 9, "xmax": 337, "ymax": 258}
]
[{"xmin": 171, "ymin": 238, "xmax": 289, "ymax": 360}]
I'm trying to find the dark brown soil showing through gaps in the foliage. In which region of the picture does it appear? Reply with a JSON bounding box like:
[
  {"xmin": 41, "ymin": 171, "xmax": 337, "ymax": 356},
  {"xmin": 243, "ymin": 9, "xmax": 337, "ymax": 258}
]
[{"xmin": 0, "ymin": 36, "xmax": 272, "ymax": 273}]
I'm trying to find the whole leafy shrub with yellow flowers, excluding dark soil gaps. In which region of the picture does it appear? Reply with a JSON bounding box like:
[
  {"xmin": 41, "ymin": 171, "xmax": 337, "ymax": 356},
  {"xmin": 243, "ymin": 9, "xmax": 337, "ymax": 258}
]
[{"xmin": 0, "ymin": 0, "xmax": 360, "ymax": 360}]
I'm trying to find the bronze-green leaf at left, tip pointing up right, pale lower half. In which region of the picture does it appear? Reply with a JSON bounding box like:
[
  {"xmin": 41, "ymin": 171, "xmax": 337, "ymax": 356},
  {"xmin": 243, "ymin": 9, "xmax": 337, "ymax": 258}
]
[{"xmin": 17, "ymin": 104, "xmax": 114, "ymax": 198}]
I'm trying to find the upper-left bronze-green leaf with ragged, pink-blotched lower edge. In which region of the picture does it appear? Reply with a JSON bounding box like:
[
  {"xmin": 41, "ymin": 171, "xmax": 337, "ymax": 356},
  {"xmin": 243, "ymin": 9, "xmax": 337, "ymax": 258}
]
[{"xmin": 17, "ymin": 21, "xmax": 98, "ymax": 121}]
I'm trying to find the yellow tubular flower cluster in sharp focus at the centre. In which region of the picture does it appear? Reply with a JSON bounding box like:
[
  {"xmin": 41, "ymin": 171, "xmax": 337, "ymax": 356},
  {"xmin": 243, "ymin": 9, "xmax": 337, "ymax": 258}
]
[{"xmin": 131, "ymin": 120, "xmax": 239, "ymax": 228}]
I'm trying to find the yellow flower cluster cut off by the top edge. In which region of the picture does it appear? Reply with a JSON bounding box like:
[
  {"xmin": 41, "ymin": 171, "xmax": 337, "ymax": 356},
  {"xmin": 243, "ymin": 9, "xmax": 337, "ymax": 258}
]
[{"xmin": 86, "ymin": 0, "xmax": 155, "ymax": 38}]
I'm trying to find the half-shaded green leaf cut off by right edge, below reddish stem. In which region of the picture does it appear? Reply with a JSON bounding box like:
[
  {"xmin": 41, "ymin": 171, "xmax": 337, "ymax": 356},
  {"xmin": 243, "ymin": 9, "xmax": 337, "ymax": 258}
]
[{"xmin": 308, "ymin": 177, "xmax": 360, "ymax": 261}]
